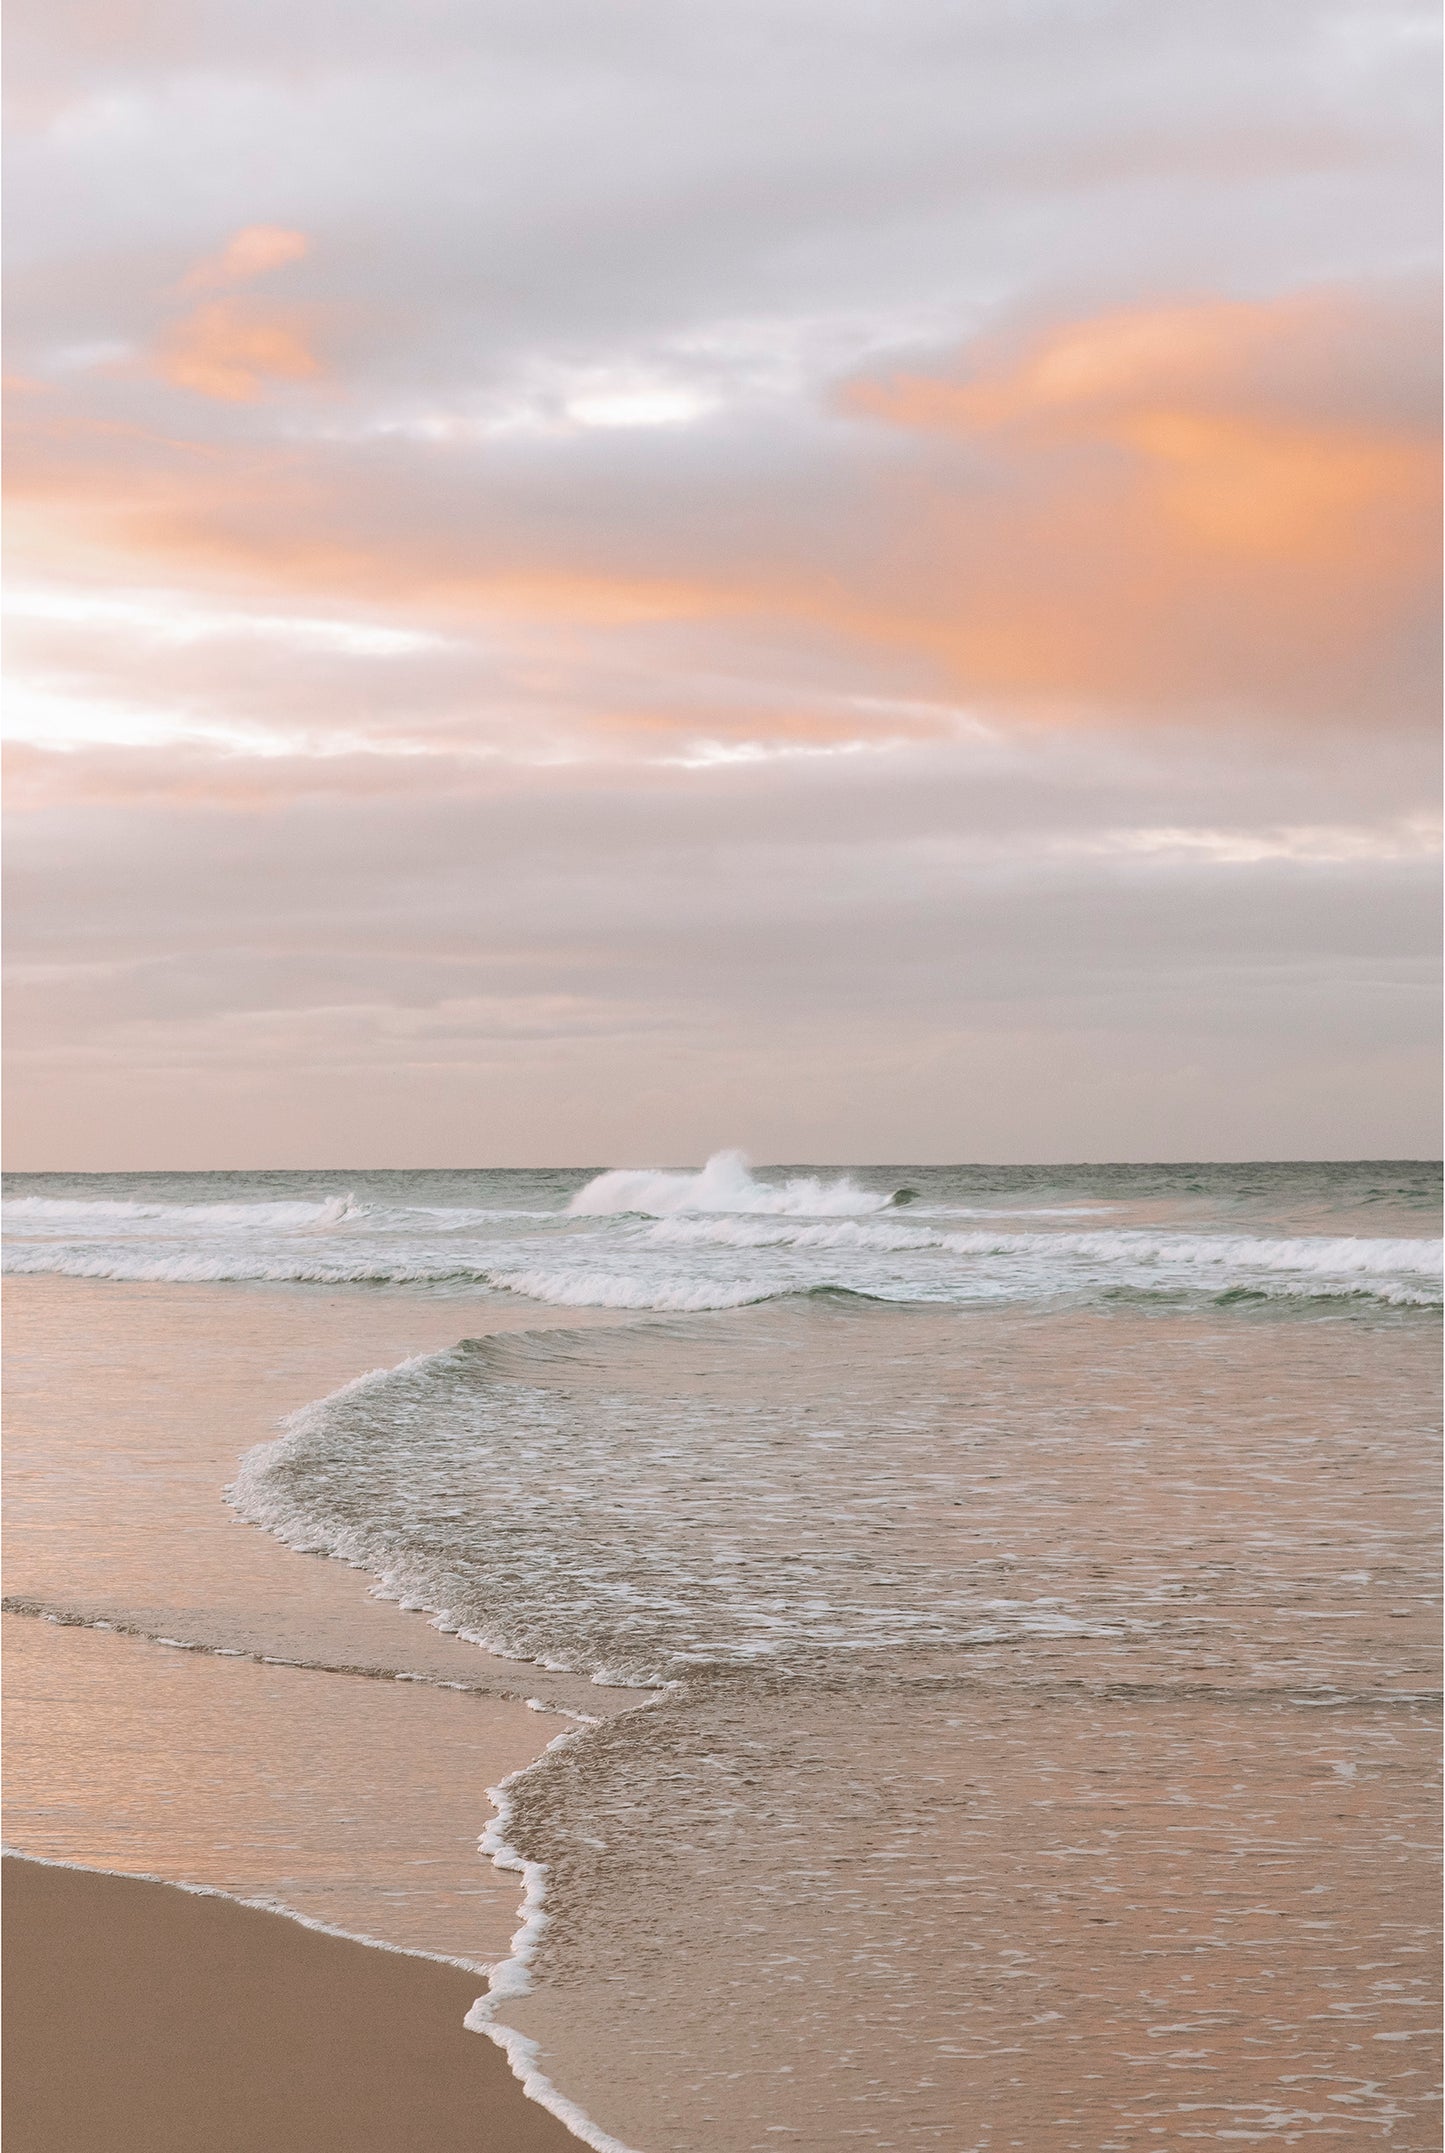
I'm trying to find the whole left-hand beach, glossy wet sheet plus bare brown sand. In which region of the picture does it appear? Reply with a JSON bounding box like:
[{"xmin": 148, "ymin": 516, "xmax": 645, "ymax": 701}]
[{"xmin": 0, "ymin": 1277, "xmax": 646, "ymax": 2153}]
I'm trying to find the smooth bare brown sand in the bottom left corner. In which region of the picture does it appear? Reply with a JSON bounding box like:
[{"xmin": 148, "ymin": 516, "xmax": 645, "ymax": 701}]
[{"xmin": 4, "ymin": 1856, "xmax": 579, "ymax": 2153}]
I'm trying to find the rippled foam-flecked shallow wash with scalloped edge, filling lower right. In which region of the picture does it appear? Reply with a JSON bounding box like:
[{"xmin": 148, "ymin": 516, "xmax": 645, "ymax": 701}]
[{"xmin": 231, "ymin": 1303, "xmax": 1434, "ymax": 2153}]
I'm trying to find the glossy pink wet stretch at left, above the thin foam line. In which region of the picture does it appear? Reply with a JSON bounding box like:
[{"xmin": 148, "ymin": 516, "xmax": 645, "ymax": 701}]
[{"xmin": 4, "ymin": 1277, "xmax": 635, "ymax": 1713}]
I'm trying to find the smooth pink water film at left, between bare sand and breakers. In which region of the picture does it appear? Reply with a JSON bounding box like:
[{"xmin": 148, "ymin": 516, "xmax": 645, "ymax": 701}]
[{"xmin": 4, "ymin": 1279, "xmax": 635, "ymax": 1989}]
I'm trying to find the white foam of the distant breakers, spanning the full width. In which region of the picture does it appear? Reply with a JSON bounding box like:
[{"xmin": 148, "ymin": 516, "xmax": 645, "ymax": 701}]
[{"xmin": 4, "ymin": 1152, "xmax": 1441, "ymax": 1311}]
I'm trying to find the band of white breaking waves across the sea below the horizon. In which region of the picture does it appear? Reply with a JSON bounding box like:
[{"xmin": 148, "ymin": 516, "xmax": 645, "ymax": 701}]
[{"xmin": 4, "ymin": 1152, "xmax": 1441, "ymax": 1313}]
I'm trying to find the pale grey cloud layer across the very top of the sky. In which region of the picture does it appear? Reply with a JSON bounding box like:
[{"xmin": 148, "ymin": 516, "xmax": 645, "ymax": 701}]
[{"xmin": 13, "ymin": 0, "xmax": 1434, "ymax": 383}]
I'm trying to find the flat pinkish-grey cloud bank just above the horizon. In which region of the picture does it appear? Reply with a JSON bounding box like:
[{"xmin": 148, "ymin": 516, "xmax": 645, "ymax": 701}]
[{"xmin": 9, "ymin": 732, "xmax": 1436, "ymax": 1165}]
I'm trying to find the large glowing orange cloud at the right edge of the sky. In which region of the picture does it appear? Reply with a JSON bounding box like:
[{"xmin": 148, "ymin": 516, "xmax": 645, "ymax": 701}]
[{"xmin": 842, "ymin": 293, "xmax": 1439, "ymax": 706}]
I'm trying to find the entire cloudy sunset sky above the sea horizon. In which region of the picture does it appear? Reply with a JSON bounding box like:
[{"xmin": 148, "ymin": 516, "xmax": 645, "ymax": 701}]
[{"xmin": 6, "ymin": 0, "xmax": 1439, "ymax": 1171}]
